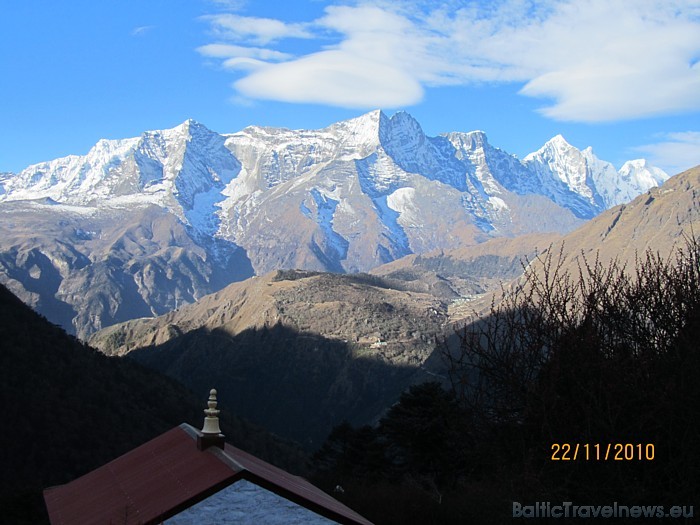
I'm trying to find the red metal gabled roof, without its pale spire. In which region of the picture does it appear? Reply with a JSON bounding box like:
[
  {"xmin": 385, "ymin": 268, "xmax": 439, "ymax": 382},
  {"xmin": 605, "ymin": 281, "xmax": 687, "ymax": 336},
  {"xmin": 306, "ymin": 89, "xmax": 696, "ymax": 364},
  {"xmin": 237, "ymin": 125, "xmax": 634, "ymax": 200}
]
[{"xmin": 44, "ymin": 424, "xmax": 371, "ymax": 525}]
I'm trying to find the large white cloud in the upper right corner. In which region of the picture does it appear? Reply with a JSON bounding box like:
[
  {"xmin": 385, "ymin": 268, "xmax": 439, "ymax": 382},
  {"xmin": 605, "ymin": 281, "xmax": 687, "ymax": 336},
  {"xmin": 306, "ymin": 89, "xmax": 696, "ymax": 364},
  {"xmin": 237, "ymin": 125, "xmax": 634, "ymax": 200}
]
[{"xmin": 516, "ymin": 0, "xmax": 700, "ymax": 122}]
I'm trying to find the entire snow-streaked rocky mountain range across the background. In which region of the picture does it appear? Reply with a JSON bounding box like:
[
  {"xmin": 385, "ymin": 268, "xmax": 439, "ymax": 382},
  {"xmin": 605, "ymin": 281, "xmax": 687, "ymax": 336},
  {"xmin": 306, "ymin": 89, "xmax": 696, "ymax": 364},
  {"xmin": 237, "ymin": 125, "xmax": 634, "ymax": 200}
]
[{"xmin": 0, "ymin": 111, "xmax": 665, "ymax": 337}]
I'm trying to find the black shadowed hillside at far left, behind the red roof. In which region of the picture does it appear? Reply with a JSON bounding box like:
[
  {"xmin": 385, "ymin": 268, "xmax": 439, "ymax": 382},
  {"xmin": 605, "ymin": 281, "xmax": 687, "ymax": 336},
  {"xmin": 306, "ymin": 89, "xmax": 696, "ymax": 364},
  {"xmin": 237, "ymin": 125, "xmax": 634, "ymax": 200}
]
[{"xmin": 0, "ymin": 286, "xmax": 304, "ymax": 524}]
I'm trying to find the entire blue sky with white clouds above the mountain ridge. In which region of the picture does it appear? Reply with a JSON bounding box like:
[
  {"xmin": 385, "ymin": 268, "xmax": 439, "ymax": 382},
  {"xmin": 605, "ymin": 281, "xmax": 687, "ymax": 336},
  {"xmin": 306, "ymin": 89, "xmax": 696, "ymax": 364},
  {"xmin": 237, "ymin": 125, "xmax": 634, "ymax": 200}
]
[{"xmin": 0, "ymin": 0, "xmax": 700, "ymax": 174}]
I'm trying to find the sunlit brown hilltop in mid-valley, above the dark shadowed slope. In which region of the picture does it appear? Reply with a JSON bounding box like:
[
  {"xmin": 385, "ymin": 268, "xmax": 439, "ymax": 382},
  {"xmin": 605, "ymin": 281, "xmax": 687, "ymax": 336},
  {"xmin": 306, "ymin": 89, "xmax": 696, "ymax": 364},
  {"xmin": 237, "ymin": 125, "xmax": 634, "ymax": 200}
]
[{"xmin": 91, "ymin": 271, "xmax": 447, "ymax": 365}]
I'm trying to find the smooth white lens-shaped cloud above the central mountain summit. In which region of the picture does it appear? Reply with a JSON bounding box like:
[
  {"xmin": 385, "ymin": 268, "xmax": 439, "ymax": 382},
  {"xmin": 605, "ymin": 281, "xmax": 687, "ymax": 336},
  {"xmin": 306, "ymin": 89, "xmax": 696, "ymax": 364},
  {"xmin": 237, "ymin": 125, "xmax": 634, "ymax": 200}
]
[{"xmin": 234, "ymin": 7, "xmax": 427, "ymax": 108}]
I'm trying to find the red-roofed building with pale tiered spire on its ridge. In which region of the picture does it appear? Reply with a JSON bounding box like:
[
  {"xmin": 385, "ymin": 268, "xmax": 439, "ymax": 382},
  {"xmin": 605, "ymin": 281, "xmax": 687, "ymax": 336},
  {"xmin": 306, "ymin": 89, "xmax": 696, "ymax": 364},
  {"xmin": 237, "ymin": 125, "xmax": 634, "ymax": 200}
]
[{"xmin": 44, "ymin": 390, "xmax": 371, "ymax": 525}]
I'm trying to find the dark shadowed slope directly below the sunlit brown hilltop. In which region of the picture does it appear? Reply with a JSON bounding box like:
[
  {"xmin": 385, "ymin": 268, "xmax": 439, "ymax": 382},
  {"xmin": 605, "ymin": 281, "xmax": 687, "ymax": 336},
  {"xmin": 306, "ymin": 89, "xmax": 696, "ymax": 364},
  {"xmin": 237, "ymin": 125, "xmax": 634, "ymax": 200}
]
[{"xmin": 127, "ymin": 325, "xmax": 428, "ymax": 450}]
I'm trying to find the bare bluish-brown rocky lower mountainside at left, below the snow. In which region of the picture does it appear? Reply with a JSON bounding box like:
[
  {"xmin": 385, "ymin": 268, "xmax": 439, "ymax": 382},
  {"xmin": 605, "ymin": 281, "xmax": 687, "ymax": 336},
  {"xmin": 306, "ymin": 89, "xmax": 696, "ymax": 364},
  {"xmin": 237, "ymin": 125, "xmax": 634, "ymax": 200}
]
[{"xmin": 0, "ymin": 201, "xmax": 252, "ymax": 337}]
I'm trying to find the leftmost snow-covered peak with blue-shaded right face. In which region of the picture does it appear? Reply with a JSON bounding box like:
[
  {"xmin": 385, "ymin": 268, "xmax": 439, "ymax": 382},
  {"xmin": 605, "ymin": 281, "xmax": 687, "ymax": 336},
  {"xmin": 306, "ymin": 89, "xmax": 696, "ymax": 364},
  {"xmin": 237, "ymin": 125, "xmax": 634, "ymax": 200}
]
[{"xmin": 0, "ymin": 119, "xmax": 240, "ymax": 227}]
